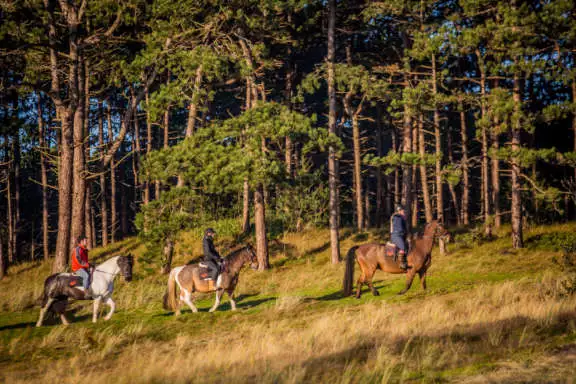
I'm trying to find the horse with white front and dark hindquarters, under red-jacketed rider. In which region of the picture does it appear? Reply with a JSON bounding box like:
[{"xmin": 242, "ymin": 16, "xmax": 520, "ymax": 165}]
[{"xmin": 36, "ymin": 254, "xmax": 134, "ymax": 327}]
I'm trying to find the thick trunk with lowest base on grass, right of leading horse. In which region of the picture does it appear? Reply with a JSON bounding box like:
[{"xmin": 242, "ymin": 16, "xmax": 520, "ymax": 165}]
[{"xmin": 512, "ymin": 73, "xmax": 524, "ymax": 248}]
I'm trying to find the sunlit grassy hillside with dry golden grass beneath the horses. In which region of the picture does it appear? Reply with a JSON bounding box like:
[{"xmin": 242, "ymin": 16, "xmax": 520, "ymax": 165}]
[{"xmin": 0, "ymin": 224, "xmax": 576, "ymax": 383}]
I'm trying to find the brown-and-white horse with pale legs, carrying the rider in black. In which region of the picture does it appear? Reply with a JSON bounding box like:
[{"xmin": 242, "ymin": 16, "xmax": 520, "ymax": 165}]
[{"xmin": 164, "ymin": 245, "xmax": 258, "ymax": 316}]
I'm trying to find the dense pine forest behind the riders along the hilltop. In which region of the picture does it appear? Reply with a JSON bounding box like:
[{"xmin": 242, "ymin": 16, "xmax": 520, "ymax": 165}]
[{"xmin": 0, "ymin": 0, "xmax": 576, "ymax": 279}]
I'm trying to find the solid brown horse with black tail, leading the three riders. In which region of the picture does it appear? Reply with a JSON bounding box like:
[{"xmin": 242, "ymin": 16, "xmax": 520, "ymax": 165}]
[{"xmin": 344, "ymin": 220, "xmax": 449, "ymax": 299}]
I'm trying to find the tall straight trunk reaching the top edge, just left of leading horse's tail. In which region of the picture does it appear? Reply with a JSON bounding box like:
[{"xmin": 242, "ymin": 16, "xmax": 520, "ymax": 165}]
[{"xmin": 326, "ymin": 0, "xmax": 340, "ymax": 264}]
